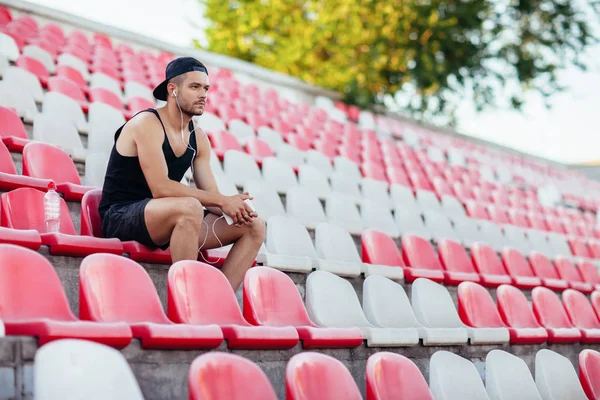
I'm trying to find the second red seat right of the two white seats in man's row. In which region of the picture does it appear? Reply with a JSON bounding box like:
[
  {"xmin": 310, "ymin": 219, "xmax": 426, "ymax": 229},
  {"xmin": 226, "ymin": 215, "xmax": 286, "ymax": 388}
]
[{"xmin": 402, "ymin": 234, "xmax": 444, "ymax": 283}]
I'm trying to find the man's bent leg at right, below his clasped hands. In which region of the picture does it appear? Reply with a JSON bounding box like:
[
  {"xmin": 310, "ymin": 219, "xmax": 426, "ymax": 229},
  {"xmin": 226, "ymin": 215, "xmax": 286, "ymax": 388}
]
[{"xmin": 198, "ymin": 214, "xmax": 265, "ymax": 290}]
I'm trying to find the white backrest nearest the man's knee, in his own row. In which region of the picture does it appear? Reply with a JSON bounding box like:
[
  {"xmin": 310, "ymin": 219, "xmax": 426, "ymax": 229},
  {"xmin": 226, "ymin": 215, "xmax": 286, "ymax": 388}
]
[{"xmin": 267, "ymin": 215, "xmax": 317, "ymax": 259}]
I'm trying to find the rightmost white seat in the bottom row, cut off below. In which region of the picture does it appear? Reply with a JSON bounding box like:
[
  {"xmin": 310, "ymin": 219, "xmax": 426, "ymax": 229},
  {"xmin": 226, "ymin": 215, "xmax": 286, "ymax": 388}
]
[{"xmin": 485, "ymin": 350, "xmax": 542, "ymax": 400}]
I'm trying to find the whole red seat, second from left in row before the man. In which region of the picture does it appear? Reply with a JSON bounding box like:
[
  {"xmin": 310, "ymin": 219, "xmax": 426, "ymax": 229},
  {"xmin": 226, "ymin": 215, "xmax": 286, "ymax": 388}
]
[{"xmin": 79, "ymin": 254, "xmax": 223, "ymax": 349}]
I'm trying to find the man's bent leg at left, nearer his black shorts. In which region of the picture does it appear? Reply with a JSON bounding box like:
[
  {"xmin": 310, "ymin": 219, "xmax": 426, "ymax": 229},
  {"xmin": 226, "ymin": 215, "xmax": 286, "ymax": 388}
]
[{"xmin": 144, "ymin": 197, "xmax": 204, "ymax": 263}]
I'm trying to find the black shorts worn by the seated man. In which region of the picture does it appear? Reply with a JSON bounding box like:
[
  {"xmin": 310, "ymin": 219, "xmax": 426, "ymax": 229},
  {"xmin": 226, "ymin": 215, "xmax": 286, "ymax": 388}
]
[{"xmin": 102, "ymin": 199, "xmax": 209, "ymax": 250}]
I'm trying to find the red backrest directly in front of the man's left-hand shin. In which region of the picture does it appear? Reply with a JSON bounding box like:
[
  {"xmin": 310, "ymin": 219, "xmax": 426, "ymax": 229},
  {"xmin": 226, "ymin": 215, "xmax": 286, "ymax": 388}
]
[{"xmin": 167, "ymin": 261, "xmax": 246, "ymax": 325}]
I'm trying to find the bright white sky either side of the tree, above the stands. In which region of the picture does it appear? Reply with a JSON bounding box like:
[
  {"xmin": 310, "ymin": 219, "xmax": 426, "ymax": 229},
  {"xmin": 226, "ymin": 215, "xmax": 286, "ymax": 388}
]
[{"xmin": 23, "ymin": 0, "xmax": 600, "ymax": 163}]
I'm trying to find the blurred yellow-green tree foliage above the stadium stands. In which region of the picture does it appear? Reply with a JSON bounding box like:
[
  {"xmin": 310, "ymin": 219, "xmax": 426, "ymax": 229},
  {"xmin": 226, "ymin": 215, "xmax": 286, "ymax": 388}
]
[{"xmin": 199, "ymin": 0, "xmax": 598, "ymax": 122}]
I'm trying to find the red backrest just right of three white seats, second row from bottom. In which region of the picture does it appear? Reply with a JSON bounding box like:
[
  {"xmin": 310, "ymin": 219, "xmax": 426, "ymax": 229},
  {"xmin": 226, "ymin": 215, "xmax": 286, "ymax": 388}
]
[{"xmin": 457, "ymin": 282, "xmax": 506, "ymax": 328}]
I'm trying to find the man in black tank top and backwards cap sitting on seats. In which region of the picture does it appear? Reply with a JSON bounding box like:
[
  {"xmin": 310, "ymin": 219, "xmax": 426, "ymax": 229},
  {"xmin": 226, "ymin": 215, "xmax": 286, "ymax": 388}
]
[{"xmin": 99, "ymin": 57, "xmax": 265, "ymax": 290}]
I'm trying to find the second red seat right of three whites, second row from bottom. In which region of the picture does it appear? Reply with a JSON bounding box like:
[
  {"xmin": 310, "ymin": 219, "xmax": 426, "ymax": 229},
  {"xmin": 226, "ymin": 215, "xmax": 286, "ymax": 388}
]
[{"xmin": 496, "ymin": 285, "xmax": 548, "ymax": 344}]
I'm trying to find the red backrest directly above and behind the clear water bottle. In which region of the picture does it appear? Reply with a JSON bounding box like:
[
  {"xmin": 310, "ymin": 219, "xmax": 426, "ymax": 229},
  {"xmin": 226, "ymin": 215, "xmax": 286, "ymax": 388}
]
[{"xmin": 23, "ymin": 142, "xmax": 81, "ymax": 185}]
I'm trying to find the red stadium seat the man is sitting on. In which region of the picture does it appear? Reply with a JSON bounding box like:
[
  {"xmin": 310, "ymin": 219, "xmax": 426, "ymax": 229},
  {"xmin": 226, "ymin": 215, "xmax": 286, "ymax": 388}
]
[{"xmin": 81, "ymin": 189, "xmax": 172, "ymax": 264}]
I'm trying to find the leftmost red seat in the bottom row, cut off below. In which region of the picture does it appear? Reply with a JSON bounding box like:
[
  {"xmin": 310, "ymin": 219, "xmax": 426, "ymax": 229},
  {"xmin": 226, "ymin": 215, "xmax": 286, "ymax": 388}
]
[{"xmin": 188, "ymin": 352, "xmax": 277, "ymax": 400}]
